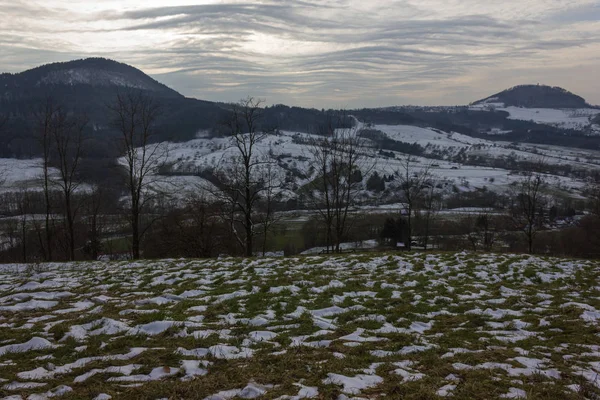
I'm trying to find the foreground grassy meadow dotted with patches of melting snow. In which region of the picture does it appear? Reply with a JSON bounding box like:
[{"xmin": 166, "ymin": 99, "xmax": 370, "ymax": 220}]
[{"xmin": 0, "ymin": 253, "xmax": 600, "ymax": 400}]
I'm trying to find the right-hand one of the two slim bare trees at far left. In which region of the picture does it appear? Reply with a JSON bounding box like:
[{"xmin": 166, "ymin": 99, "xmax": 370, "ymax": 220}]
[{"xmin": 52, "ymin": 108, "xmax": 87, "ymax": 261}]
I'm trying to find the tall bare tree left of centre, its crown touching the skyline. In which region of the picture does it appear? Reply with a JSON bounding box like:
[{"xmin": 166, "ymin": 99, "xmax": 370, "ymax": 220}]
[{"xmin": 209, "ymin": 97, "xmax": 273, "ymax": 257}]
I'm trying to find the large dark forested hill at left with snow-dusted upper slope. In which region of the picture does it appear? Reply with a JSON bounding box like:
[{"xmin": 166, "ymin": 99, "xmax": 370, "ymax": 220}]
[{"xmin": 0, "ymin": 58, "xmax": 232, "ymax": 157}]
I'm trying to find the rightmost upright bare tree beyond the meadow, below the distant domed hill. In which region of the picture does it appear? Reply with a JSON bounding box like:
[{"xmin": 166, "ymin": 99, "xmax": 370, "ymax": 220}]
[{"xmin": 511, "ymin": 161, "xmax": 546, "ymax": 253}]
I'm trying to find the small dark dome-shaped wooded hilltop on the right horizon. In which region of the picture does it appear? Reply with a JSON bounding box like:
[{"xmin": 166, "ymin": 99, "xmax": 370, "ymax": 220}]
[{"xmin": 473, "ymin": 85, "xmax": 592, "ymax": 109}]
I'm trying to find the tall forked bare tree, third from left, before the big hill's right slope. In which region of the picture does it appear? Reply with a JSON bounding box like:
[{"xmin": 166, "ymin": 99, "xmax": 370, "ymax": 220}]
[{"xmin": 109, "ymin": 90, "xmax": 168, "ymax": 259}]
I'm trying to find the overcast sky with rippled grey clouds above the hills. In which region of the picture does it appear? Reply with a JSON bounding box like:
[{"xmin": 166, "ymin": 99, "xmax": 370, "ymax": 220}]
[{"xmin": 0, "ymin": 0, "xmax": 600, "ymax": 108}]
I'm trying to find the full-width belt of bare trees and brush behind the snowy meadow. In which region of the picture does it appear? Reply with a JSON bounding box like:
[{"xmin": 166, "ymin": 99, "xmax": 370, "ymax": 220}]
[{"xmin": 0, "ymin": 91, "xmax": 600, "ymax": 262}]
